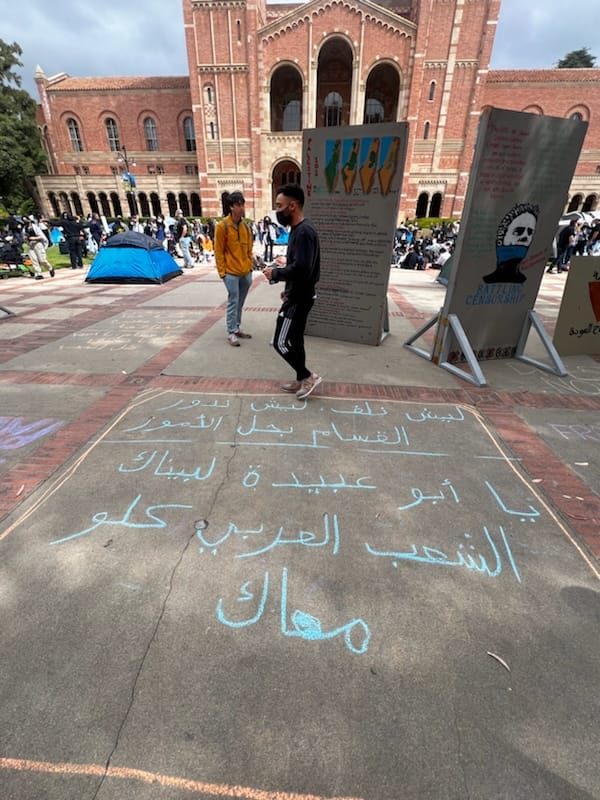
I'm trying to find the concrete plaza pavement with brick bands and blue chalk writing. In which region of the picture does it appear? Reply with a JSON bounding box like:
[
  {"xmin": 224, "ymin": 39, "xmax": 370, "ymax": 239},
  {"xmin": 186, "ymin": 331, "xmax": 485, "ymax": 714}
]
[{"xmin": 0, "ymin": 268, "xmax": 600, "ymax": 800}]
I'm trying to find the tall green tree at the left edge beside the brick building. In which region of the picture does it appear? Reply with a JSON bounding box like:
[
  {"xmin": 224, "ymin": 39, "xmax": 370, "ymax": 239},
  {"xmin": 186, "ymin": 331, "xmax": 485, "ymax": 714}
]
[{"xmin": 0, "ymin": 39, "xmax": 46, "ymax": 210}]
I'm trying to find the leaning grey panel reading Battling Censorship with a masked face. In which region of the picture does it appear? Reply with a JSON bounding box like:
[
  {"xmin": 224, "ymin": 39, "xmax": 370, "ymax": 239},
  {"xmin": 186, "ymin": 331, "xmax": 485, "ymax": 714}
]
[{"xmin": 432, "ymin": 108, "xmax": 587, "ymax": 364}]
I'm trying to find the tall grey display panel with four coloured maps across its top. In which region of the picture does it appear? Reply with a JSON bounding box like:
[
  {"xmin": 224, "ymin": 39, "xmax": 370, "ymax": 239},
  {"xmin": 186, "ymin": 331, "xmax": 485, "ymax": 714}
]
[{"xmin": 302, "ymin": 122, "xmax": 408, "ymax": 345}]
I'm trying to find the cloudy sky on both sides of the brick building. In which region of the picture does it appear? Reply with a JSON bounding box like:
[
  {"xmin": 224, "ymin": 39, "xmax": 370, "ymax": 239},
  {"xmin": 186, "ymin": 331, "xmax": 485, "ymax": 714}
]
[{"xmin": 0, "ymin": 0, "xmax": 600, "ymax": 101}]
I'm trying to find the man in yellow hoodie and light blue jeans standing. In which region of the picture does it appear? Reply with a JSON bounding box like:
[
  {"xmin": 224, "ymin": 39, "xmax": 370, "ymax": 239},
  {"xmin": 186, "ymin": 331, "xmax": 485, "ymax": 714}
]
[{"xmin": 215, "ymin": 192, "xmax": 253, "ymax": 347}]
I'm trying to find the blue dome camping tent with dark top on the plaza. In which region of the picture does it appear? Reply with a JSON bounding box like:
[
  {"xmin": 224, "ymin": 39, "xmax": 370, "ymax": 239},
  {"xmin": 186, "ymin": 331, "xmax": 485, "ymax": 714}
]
[{"xmin": 85, "ymin": 231, "xmax": 182, "ymax": 283}]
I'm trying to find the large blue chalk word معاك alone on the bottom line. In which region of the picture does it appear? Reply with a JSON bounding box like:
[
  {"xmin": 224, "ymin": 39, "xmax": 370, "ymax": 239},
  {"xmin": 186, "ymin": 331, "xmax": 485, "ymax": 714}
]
[{"xmin": 216, "ymin": 567, "xmax": 371, "ymax": 655}]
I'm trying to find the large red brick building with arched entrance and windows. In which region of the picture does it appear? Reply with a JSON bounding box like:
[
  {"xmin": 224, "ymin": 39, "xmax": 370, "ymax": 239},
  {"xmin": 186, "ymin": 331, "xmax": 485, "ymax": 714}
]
[{"xmin": 36, "ymin": 0, "xmax": 600, "ymax": 218}]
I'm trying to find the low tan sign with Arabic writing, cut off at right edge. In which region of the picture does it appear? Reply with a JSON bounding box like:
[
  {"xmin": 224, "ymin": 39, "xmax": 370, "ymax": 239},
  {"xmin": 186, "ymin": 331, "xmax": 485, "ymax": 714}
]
[{"xmin": 553, "ymin": 256, "xmax": 600, "ymax": 356}]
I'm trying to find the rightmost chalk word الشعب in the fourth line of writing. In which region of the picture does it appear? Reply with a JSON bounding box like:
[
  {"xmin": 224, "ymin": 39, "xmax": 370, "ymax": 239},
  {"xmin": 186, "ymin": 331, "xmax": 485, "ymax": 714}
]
[{"xmin": 365, "ymin": 525, "xmax": 521, "ymax": 583}]
